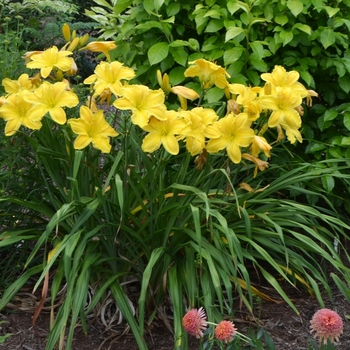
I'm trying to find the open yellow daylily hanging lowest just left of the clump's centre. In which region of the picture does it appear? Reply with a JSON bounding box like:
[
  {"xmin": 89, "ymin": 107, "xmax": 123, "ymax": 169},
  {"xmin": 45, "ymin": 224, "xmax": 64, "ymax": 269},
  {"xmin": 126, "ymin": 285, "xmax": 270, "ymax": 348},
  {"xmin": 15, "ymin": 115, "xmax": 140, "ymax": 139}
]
[{"xmin": 141, "ymin": 111, "xmax": 186, "ymax": 155}]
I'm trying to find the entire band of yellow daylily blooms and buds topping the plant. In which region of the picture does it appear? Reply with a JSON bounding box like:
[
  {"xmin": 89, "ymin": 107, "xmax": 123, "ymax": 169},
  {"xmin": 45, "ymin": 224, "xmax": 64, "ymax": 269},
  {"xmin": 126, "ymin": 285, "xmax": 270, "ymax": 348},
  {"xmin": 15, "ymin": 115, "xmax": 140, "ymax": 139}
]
[{"xmin": 0, "ymin": 25, "xmax": 317, "ymax": 176}]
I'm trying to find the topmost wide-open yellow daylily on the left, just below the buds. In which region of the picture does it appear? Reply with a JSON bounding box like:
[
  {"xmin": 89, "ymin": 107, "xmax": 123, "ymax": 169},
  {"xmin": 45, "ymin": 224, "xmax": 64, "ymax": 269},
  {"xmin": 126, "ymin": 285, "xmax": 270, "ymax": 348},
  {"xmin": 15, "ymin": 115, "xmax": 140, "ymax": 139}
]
[{"xmin": 27, "ymin": 46, "xmax": 72, "ymax": 78}]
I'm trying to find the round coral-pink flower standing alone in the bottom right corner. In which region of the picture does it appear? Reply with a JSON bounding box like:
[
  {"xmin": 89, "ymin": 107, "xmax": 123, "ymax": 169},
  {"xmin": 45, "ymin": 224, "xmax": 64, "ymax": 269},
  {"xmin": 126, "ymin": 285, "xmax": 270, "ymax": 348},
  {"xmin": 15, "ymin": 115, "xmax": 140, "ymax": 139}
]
[{"xmin": 310, "ymin": 309, "xmax": 343, "ymax": 344}]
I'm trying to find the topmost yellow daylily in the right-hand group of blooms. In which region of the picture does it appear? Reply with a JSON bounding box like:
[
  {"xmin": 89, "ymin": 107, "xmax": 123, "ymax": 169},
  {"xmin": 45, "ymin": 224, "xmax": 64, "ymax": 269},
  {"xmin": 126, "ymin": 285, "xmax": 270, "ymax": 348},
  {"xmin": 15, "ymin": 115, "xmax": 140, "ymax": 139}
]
[{"xmin": 261, "ymin": 66, "xmax": 308, "ymax": 98}]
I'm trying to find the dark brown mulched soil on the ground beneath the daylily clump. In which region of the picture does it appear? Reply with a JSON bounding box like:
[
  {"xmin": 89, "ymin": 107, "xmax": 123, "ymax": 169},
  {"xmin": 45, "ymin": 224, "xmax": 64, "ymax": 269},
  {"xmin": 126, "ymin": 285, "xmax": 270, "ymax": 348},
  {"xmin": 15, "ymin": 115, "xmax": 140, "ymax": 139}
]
[{"xmin": 0, "ymin": 289, "xmax": 350, "ymax": 350}]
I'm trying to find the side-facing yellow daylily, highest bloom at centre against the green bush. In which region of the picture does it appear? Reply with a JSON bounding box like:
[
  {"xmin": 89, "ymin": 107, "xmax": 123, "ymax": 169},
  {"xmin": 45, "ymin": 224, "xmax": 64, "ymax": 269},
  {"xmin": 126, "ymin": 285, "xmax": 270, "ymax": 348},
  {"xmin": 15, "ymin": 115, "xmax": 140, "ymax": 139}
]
[{"xmin": 184, "ymin": 58, "xmax": 230, "ymax": 89}]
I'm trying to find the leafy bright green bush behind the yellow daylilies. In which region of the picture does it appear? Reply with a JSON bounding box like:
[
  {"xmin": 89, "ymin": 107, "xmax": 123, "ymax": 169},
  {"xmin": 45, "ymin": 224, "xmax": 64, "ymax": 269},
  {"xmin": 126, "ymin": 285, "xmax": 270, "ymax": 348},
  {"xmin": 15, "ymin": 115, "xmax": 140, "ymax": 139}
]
[{"xmin": 86, "ymin": 0, "xmax": 350, "ymax": 215}]
